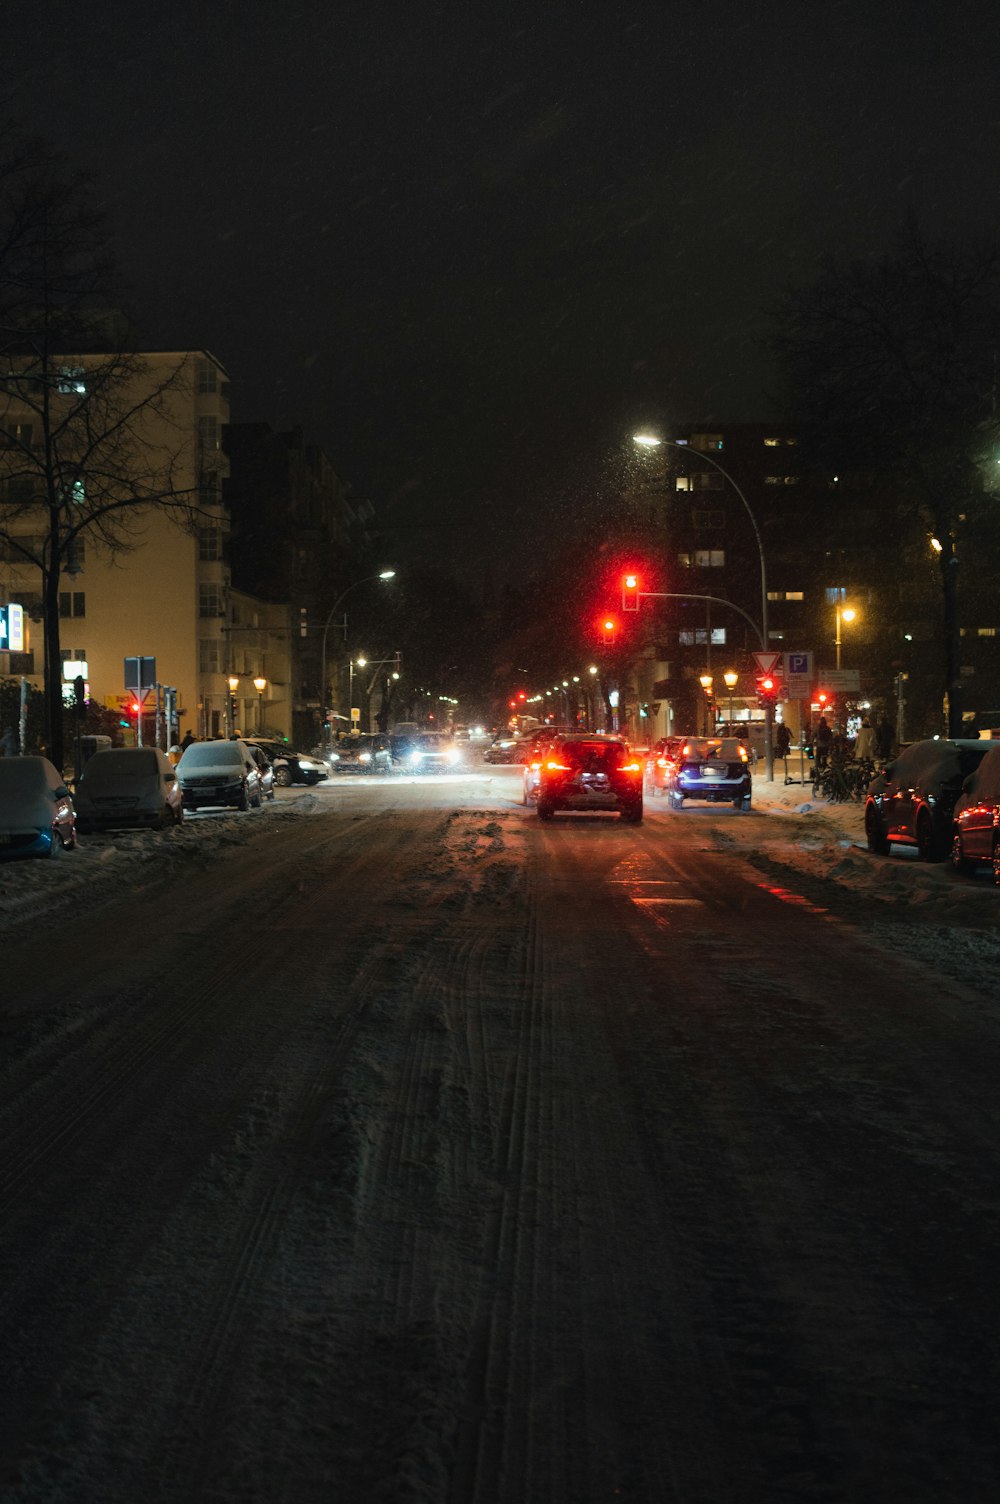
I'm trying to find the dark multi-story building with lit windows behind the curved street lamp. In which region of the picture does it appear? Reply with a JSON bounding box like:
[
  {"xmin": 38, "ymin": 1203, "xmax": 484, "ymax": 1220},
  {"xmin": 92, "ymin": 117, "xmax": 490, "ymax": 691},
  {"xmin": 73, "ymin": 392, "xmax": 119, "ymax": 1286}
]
[{"xmin": 636, "ymin": 424, "xmax": 1000, "ymax": 735}]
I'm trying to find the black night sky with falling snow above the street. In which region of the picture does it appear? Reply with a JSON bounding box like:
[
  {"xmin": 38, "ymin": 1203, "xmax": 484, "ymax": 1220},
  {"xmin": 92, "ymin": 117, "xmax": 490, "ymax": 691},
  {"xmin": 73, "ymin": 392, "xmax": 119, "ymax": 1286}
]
[{"xmin": 0, "ymin": 0, "xmax": 1000, "ymax": 574}]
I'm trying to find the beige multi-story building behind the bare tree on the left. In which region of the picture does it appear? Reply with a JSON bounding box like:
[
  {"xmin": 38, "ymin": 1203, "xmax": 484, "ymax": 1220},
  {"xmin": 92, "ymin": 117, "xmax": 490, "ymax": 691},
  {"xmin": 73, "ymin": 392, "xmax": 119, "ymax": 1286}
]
[{"xmin": 0, "ymin": 350, "xmax": 290, "ymax": 752}]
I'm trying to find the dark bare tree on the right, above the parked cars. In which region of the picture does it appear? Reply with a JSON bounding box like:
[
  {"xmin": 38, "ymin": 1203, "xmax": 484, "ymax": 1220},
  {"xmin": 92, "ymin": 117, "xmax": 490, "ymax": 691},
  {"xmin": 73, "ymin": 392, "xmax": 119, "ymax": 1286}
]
[{"xmin": 774, "ymin": 224, "xmax": 1000, "ymax": 735}]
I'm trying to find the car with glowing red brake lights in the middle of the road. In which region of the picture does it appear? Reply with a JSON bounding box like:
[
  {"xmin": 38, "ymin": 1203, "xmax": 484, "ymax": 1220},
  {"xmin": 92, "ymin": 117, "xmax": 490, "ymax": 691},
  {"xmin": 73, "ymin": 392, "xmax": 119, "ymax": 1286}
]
[{"xmin": 535, "ymin": 732, "xmax": 642, "ymax": 824}]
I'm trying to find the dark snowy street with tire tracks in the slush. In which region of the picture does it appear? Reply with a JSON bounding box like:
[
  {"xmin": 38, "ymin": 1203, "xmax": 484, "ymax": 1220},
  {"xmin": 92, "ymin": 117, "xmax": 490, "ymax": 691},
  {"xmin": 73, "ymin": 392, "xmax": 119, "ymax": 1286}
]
[{"xmin": 0, "ymin": 767, "xmax": 1000, "ymax": 1504}]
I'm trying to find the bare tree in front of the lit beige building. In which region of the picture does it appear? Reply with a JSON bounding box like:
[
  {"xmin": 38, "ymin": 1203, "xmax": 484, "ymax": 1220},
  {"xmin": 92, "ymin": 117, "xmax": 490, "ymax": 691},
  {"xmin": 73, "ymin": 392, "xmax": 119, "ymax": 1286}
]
[{"xmin": 0, "ymin": 128, "xmax": 197, "ymax": 766}]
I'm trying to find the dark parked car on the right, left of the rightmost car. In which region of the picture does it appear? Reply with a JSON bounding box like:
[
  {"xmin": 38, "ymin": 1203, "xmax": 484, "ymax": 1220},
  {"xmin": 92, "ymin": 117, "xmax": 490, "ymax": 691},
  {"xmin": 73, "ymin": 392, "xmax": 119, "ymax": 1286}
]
[{"xmin": 865, "ymin": 737, "xmax": 989, "ymax": 862}]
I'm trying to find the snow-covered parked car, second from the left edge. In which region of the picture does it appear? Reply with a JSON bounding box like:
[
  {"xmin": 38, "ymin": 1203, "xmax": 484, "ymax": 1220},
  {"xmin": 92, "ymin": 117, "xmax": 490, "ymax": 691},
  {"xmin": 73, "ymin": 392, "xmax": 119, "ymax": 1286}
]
[{"xmin": 74, "ymin": 747, "xmax": 183, "ymax": 833}]
